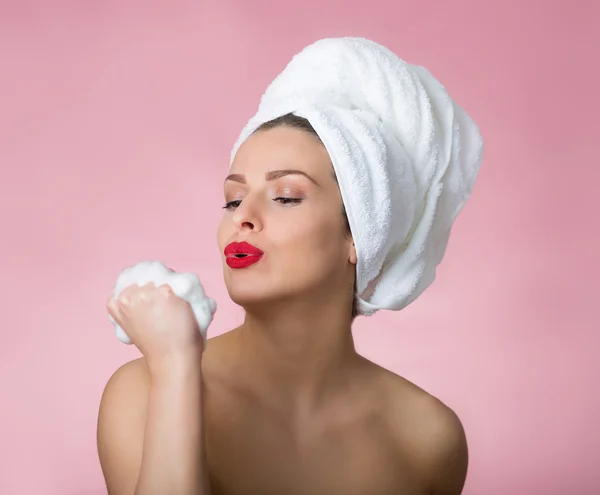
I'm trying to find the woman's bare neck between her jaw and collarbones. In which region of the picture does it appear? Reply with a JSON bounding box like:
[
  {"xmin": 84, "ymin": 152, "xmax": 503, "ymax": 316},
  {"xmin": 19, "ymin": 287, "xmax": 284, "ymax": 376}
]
[{"xmin": 232, "ymin": 300, "xmax": 358, "ymax": 409}]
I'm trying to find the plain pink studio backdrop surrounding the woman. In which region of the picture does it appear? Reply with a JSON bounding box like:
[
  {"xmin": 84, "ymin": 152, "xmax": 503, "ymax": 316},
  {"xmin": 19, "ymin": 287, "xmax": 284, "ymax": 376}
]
[{"xmin": 0, "ymin": 0, "xmax": 600, "ymax": 495}]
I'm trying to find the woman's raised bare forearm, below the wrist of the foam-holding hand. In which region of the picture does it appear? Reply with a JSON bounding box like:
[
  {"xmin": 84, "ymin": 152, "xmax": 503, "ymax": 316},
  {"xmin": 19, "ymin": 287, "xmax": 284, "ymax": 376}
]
[{"xmin": 135, "ymin": 352, "xmax": 210, "ymax": 495}]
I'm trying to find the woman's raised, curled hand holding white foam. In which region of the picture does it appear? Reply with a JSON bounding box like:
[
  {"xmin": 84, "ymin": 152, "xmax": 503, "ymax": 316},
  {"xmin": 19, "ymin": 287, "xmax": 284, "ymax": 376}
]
[{"xmin": 107, "ymin": 282, "xmax": 202, "ymax": 372}]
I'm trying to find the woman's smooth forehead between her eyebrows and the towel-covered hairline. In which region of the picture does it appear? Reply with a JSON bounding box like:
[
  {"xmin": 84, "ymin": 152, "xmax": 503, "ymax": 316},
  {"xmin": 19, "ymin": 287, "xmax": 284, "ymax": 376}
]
[{"xmin": 231, "ymin": 126, "xmax": 332, "ymax": 176}]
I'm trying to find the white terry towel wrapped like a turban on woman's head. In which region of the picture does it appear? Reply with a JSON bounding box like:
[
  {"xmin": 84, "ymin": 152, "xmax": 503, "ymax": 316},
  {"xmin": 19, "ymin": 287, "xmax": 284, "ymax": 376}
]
[{"xmin": 231, "ymin": 38, "xmax": 483, "ymax": 315}]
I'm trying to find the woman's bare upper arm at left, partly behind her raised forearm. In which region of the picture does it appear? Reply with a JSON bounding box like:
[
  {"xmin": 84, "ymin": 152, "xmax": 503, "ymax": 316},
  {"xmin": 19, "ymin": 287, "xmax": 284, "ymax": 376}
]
[{"xmin": 97, "ymin": 359, "xmax": 149, "ymax": 495}]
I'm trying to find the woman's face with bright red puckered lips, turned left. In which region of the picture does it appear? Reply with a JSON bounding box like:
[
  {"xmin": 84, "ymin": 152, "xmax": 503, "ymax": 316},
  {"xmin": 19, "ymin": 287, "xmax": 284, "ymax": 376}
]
[{"xmin": 217, "ymin": 127, "xmax": 356, "ymax": 306}]
